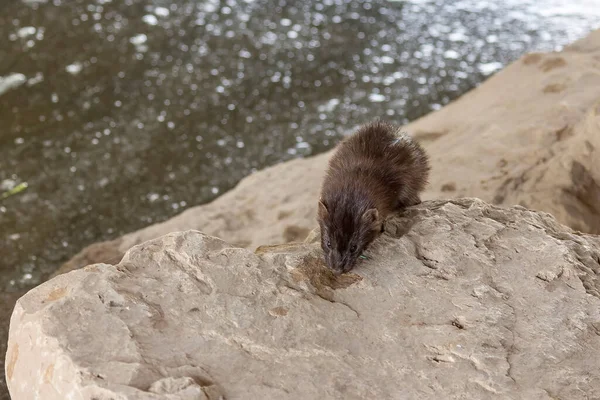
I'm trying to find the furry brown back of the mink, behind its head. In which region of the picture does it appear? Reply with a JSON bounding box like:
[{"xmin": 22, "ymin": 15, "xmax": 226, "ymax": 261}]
[{"xmin": 322, "ymin": 122, "xmax": 430, "ymax": 212}]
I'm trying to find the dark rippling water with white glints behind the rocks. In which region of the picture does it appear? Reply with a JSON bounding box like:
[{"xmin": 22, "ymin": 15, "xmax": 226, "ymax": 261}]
[{"xmin": 0, "ymin": 0, "xmax": 600, "ymax": 290}]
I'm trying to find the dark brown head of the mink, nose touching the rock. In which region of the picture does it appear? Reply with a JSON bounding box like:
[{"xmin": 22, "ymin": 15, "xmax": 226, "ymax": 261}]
[{"xmin": 318, "ymin": 200, "xmax": 382, "ymax": 274}]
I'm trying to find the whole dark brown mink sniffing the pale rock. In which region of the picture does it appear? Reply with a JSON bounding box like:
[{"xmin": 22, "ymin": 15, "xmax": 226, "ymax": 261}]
[{"xmin": 317, "ymin": 122, "xmax": 430, "ymax": 274}]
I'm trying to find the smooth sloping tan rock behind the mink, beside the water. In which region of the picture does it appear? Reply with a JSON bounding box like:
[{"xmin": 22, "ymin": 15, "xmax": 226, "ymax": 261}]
[{"xmin": 59, "ymin": 30, "xmax": 600, "ymax": 273}]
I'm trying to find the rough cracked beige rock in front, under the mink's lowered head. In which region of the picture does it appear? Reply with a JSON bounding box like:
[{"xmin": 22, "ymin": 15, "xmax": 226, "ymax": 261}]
[{"xmin": 6, "ymin": 199, "xmax": 600, "ymax": 400}]
